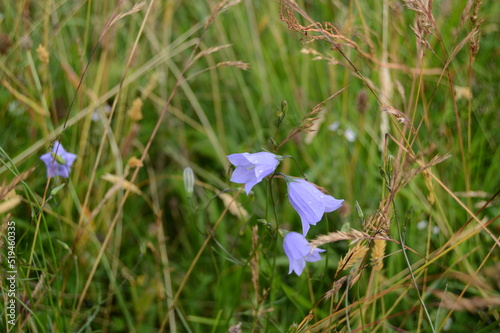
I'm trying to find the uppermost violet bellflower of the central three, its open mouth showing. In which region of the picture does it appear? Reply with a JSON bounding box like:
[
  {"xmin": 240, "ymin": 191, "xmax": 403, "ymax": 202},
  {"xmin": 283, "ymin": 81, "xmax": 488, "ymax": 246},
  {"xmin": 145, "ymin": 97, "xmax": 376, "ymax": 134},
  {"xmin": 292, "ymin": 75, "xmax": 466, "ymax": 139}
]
[{"xmin": 227, "ymin": 152, "xmax": 282, "ymax": 194}]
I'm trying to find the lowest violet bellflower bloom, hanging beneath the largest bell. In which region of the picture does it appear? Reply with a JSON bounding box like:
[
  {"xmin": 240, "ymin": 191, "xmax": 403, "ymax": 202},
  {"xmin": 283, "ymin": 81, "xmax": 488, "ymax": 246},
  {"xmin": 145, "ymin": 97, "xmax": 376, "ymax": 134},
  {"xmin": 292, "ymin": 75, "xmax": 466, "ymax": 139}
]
[{"xmin": 283, "ymin": 232, "xmax": 325, "ymax": 275}]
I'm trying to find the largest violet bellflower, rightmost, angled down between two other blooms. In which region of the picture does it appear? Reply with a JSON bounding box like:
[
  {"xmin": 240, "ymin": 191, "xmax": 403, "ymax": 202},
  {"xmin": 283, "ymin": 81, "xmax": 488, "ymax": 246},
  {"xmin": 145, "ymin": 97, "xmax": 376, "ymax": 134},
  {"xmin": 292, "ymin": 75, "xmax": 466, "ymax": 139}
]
[{"xmin": 285, "ymin": 176, "xmax": 344, "ymax": 236}]
